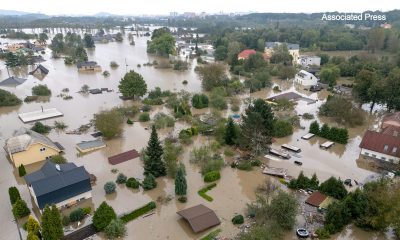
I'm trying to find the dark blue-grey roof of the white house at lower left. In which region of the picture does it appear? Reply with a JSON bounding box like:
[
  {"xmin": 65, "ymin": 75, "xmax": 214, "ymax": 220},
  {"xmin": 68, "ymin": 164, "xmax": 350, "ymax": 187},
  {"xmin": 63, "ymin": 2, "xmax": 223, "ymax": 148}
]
[{"xmin": 24, "ymin": 160, "xmax": 90, "ymax": 197}]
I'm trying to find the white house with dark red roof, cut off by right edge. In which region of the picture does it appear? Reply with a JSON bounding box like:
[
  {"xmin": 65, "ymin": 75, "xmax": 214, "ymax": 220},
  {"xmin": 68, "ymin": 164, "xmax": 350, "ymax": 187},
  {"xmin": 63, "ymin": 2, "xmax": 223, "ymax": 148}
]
[{"xmin": 360, "ymin": 112, "xmax": 400, "ymax": 164}]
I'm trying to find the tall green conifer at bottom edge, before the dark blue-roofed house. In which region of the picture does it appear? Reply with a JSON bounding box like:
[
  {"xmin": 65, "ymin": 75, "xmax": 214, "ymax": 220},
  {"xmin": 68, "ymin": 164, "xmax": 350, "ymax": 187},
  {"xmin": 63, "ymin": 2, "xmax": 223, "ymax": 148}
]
[{"xmin": 42, "ymin": 205, "xmax": 64, "ymax": 240}]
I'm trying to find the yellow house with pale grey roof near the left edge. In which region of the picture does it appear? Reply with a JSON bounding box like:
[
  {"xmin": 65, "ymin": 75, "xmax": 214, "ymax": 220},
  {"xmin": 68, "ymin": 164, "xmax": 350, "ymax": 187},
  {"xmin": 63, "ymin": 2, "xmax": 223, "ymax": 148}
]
[{"xmin": 4, "ymin": 128, "xmax": 63, "ymax": 167}]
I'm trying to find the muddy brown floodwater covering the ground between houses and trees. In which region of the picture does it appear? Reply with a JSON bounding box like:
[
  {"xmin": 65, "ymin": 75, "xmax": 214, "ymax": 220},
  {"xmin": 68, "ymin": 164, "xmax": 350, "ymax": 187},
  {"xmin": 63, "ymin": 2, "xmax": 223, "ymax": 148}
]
[{"xmin": 0, "ymin": 31, "xmax": 391, "ymax": 240}]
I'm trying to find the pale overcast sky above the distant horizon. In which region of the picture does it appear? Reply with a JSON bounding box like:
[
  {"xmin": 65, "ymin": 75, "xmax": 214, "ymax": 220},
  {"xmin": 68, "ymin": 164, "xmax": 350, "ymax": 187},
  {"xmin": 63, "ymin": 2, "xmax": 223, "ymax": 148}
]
[{"xmin": 0, "ymin": 0, "xmax": 400, "ymax": 15}]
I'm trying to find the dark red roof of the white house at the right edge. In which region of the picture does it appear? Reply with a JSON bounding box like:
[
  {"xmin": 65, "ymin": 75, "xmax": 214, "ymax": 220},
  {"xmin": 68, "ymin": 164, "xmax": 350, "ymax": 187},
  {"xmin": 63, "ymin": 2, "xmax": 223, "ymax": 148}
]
[{"xmin": 360, "ymin": 130, "xmax": 400, "ymax": 157}]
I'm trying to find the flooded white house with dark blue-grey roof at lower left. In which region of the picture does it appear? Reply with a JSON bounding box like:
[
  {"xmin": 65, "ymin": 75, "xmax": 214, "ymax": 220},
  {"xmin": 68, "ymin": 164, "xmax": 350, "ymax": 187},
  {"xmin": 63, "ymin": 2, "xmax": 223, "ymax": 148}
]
[{"xmin": 24, "ymin": 160, "xmax": 92, "ymax": 209}]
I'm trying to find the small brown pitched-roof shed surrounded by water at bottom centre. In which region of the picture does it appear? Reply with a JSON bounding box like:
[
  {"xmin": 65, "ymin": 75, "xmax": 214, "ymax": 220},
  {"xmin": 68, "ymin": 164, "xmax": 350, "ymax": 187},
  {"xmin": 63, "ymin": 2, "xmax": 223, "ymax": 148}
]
[{"xmin": 177, "ymin": 204, "xmax": 221, "ymax": 233}]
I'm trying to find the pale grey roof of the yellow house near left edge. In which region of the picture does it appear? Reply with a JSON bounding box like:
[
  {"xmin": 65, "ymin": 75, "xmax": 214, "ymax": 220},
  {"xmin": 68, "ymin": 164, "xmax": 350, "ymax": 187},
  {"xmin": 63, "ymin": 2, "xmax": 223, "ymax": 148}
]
[{"xmin": 4, "ymin": 128, "xmax": 62, "ymax": 154}]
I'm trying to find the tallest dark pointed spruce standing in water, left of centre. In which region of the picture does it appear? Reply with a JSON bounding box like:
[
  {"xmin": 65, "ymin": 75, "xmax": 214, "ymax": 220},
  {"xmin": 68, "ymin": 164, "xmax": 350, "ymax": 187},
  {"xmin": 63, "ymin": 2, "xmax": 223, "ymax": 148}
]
[{"xmin": 144, "ymin": 125, "xmax": 167, "ymax": 178}]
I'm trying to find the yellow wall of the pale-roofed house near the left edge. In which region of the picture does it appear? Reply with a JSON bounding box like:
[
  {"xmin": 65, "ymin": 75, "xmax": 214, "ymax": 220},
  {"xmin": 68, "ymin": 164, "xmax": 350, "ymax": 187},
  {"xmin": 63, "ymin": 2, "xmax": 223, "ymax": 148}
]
[{"xmin": 10, "ymin": 143, "xmax": 60, "ymax": 167}]
